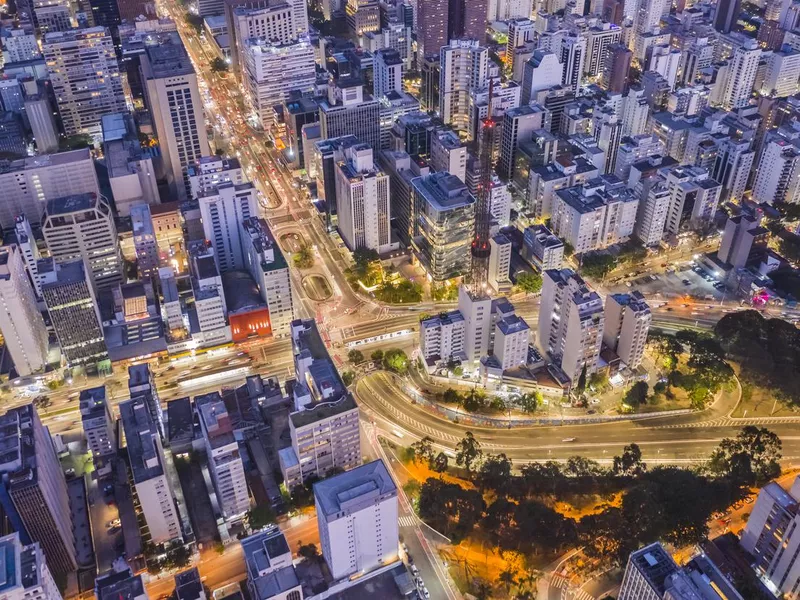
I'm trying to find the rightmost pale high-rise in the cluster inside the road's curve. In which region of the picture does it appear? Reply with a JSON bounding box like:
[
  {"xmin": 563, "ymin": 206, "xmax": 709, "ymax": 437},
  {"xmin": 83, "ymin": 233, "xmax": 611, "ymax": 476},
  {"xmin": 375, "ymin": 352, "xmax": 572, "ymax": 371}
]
[{"xmin": 603, "ymin": 291, "xmax": 653, "ymax": 369}]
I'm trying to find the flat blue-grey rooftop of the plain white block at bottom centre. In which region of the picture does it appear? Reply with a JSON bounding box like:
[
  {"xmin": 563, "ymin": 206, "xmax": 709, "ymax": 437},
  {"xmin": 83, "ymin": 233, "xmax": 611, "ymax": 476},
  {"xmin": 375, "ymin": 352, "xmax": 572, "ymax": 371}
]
[{"xmin": 314, "ymin": 460, "xmax": 397, "ymax": 519}]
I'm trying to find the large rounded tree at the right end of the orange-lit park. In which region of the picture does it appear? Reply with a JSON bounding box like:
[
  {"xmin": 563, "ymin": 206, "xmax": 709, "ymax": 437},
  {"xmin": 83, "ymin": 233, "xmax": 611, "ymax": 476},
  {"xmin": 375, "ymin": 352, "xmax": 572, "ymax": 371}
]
[{"xmin": 709, "ymin": 425, "xmax": 783, "ymax": 485}]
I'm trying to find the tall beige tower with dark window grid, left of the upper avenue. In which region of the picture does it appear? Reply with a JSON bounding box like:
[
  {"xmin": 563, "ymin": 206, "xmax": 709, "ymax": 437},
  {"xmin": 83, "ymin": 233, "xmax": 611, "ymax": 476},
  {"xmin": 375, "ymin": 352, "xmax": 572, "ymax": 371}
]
[{"xmin": 141, "ymin": 32, "xmax": 211, "ymax": 200}]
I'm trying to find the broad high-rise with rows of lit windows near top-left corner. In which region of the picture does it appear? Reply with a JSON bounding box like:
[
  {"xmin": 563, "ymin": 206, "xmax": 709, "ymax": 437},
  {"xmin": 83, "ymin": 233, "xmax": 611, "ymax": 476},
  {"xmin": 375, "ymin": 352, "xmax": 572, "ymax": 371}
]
[{"xmin": 42, "ymin": 27, "xmax": 125, "ymax": 140}]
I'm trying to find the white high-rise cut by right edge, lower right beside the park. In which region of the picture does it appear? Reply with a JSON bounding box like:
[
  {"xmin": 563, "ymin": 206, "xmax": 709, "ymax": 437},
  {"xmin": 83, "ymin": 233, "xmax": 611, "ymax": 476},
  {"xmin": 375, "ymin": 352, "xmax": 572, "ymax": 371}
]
[{"xmin": 741, "ymin": 477, "xmax": 800, "ymax": 600}]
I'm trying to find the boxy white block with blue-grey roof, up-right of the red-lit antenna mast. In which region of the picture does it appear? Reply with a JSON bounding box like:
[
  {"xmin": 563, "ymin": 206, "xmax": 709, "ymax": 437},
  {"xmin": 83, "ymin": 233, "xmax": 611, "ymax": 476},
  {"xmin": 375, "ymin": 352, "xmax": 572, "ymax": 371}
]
[{"xmin": 551, "ymin": 176, "xmax": 639, "ymax": 253}]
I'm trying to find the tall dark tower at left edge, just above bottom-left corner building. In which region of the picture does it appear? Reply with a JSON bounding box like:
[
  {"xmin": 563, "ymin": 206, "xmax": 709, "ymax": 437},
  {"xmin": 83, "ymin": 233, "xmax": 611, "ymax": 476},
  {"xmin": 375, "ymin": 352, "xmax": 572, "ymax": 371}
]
[{"xmin": 0, "ymin": 404, "xmax": 77, "ymax": 577}]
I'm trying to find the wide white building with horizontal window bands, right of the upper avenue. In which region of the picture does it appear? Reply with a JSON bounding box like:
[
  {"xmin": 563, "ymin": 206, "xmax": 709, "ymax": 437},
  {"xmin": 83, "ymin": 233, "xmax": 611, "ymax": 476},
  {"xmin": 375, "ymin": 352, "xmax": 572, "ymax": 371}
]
[{"xmin": 243, "ymin": 37, "xmax": 317, "ymax": 129}]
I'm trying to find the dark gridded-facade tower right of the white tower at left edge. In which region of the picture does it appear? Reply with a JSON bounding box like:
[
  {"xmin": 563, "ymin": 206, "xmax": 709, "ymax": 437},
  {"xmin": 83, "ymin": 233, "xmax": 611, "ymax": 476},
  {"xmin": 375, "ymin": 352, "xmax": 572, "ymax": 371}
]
[{"xmin": 37, "ymin": 258, "xmax": 108, "ymax": 364}]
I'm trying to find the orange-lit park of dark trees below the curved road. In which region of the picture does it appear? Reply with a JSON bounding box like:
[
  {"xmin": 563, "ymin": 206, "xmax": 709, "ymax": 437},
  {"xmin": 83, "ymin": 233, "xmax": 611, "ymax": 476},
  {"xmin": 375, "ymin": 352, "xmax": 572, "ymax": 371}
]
[{"xmin": 404, "ymin": 426, "xmax": 782, "ymax": 598}]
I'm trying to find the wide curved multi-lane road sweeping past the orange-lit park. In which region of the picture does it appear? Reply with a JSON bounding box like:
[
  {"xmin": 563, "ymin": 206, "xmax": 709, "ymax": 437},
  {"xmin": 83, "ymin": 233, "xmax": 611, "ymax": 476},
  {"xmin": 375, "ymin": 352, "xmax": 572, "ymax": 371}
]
[{"xmin": 355, "ymin": 373, "xmax": 800, "ymax": 463}]
